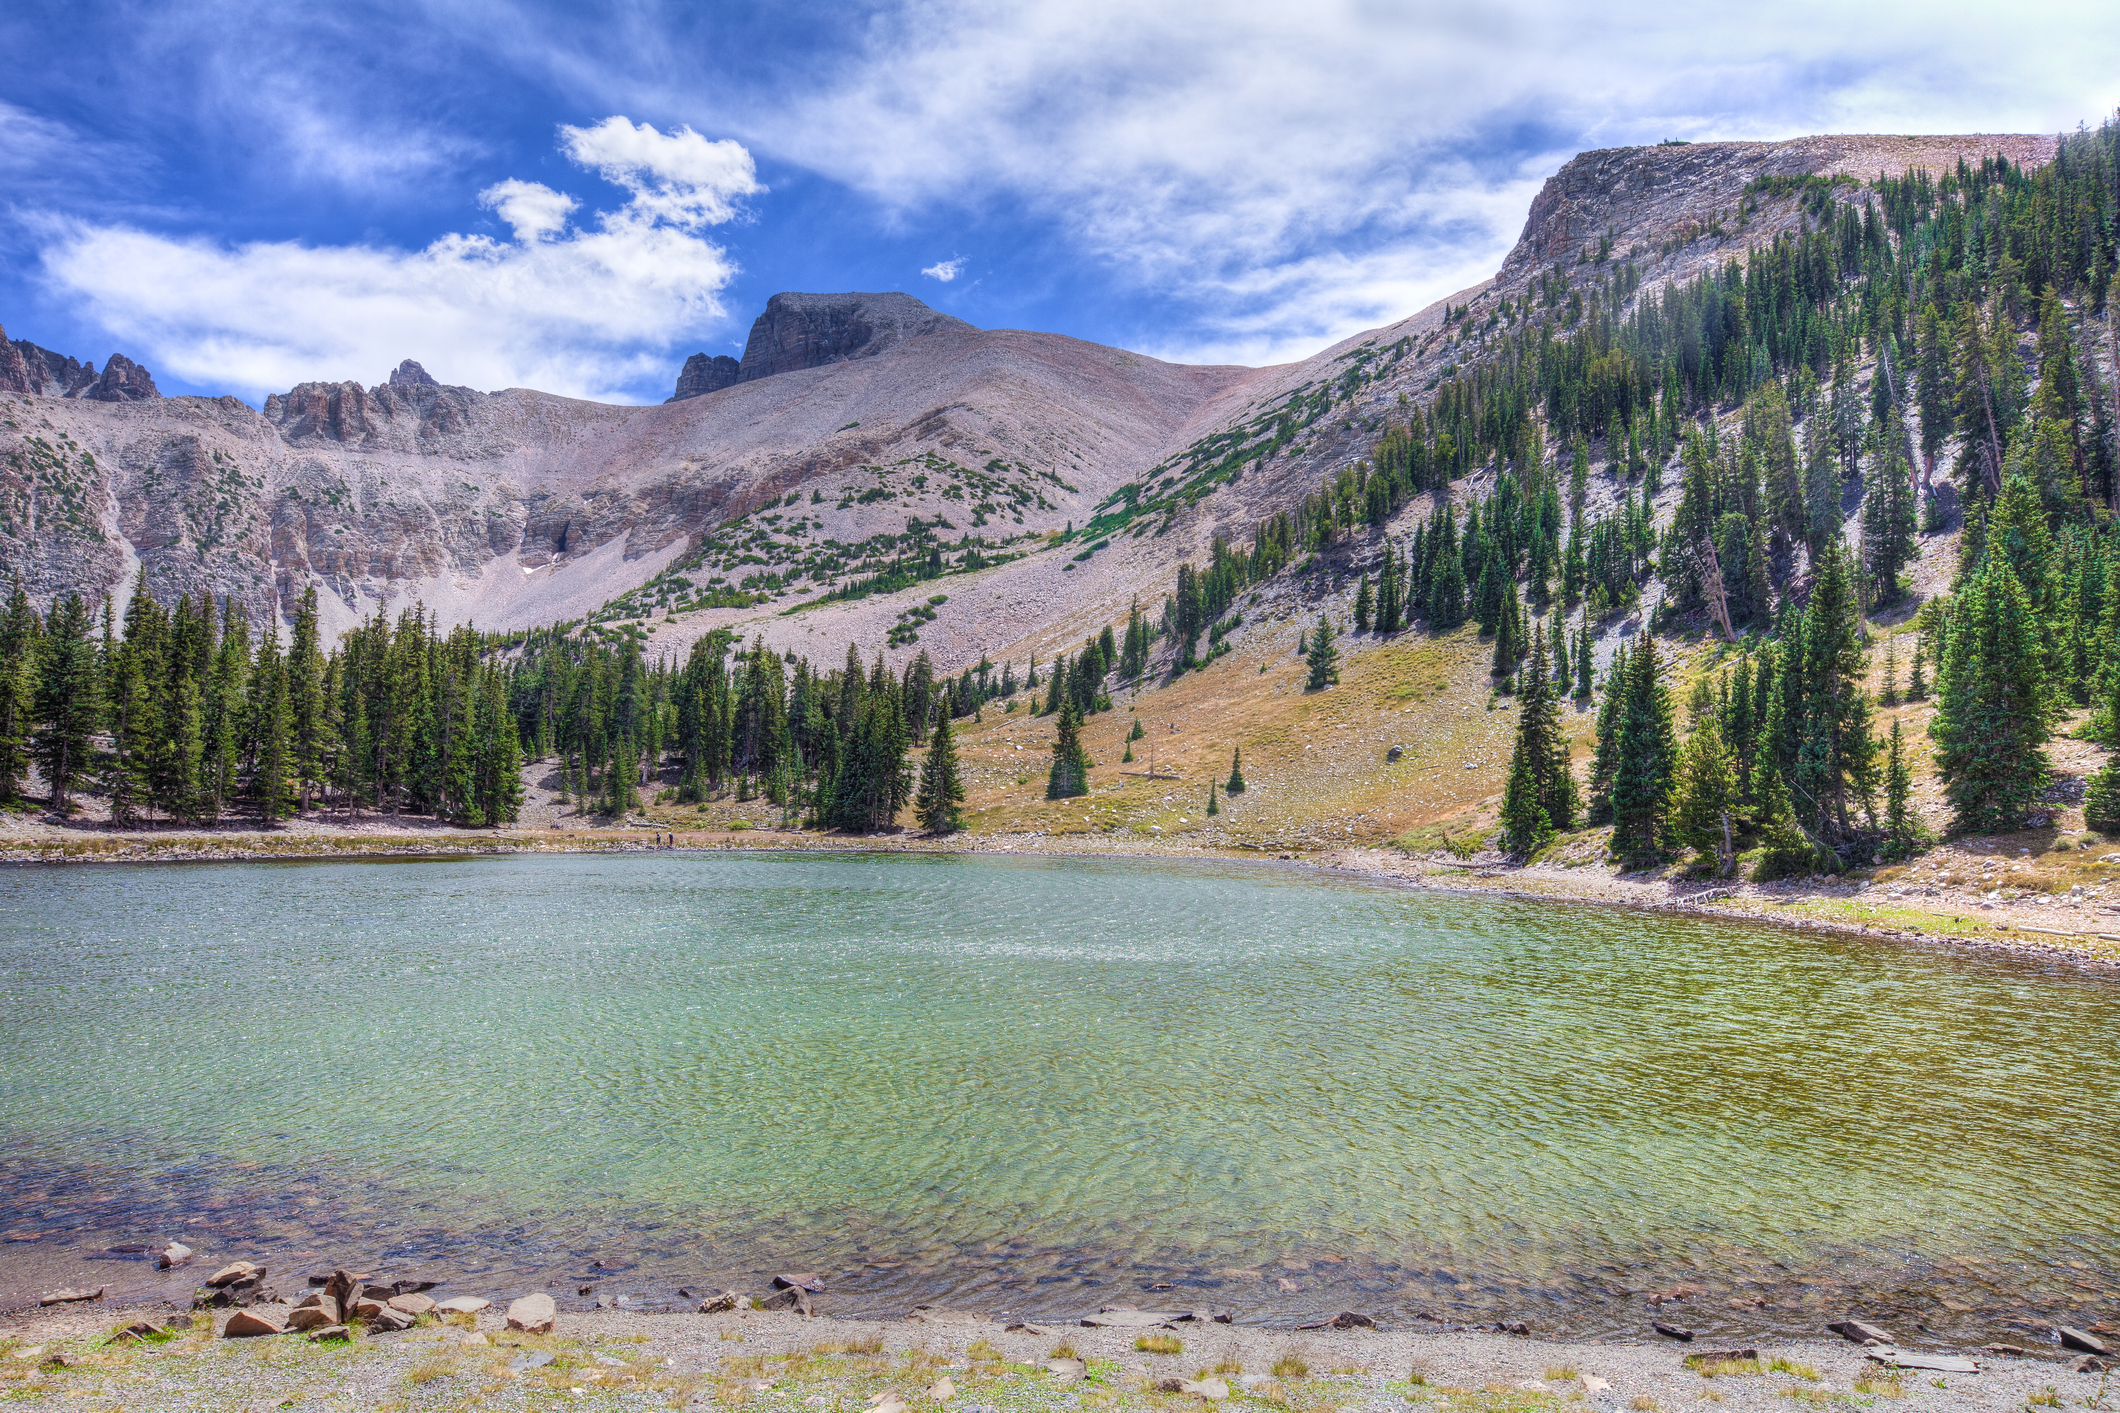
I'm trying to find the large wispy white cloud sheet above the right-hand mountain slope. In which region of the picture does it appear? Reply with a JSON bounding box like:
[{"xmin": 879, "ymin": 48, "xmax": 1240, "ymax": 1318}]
[{"xmin": 686, "ymin": 0, "xmax": 2112, "ymax": 370}]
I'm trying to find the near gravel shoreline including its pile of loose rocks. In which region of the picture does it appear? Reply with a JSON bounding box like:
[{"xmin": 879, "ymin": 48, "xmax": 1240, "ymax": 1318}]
[{"xmin": 0, "ymin": 1263, "xmax": 2120, "ymax": 1413}]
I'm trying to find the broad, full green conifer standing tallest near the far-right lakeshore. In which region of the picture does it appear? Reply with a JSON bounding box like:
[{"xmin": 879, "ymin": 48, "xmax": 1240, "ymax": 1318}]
[{"xmin": 1929, "ymin": 555, "xmax": 2054, "ymax": 833}]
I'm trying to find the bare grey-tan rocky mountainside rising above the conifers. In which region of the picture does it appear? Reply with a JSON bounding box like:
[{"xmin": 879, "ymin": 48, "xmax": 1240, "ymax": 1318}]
[{"xmin": 0, "ymin": 136, "xmax": 2054, "ymax": 669}]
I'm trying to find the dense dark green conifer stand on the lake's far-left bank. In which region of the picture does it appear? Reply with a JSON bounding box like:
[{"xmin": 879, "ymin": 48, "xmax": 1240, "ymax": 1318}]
[{"xmin": 0, "ymin": 580, "xmax": 522, "ymax": 826}]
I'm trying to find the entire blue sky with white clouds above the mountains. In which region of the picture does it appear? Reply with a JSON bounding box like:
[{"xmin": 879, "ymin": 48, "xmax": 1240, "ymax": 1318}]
[{"xmin": 0, "ymin": 0, "xmax": 2120, "ymax": 403}]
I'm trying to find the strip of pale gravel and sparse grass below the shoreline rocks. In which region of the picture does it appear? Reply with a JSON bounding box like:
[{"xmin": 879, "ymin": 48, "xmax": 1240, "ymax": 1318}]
[{"xmin": 0, "ymin": 1292, "xmax": 2112, "ymax": 1413}]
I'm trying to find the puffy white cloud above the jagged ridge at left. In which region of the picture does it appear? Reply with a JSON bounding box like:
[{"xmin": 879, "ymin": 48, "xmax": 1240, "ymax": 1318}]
[{"xmin": 40, "ymin": 117, "xmax": 761, "ymax": 398}]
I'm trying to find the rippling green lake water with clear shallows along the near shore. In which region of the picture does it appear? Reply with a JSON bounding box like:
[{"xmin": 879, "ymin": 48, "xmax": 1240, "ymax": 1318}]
[{"xmin": 0, "ymin": 854, "xmax": 2120, "ymax": 1339}]
